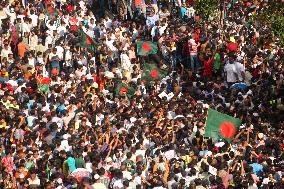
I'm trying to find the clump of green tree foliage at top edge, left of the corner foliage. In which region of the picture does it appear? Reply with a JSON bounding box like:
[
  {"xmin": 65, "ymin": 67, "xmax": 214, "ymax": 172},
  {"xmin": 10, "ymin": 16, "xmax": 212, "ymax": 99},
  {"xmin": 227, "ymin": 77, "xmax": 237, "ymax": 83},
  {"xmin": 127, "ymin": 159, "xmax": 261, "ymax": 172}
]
[{"xmin": 194, "ymin": 0, "xmax": 220, "ymax": 20}]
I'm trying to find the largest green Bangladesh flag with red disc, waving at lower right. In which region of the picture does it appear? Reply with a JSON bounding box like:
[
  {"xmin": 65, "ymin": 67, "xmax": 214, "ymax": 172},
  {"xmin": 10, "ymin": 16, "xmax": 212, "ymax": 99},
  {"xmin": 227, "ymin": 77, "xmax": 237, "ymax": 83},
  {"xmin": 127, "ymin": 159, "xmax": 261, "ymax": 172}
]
[{"xmin": 205, "ymin": 109, "xmax": 242, "ymax": 142}]
